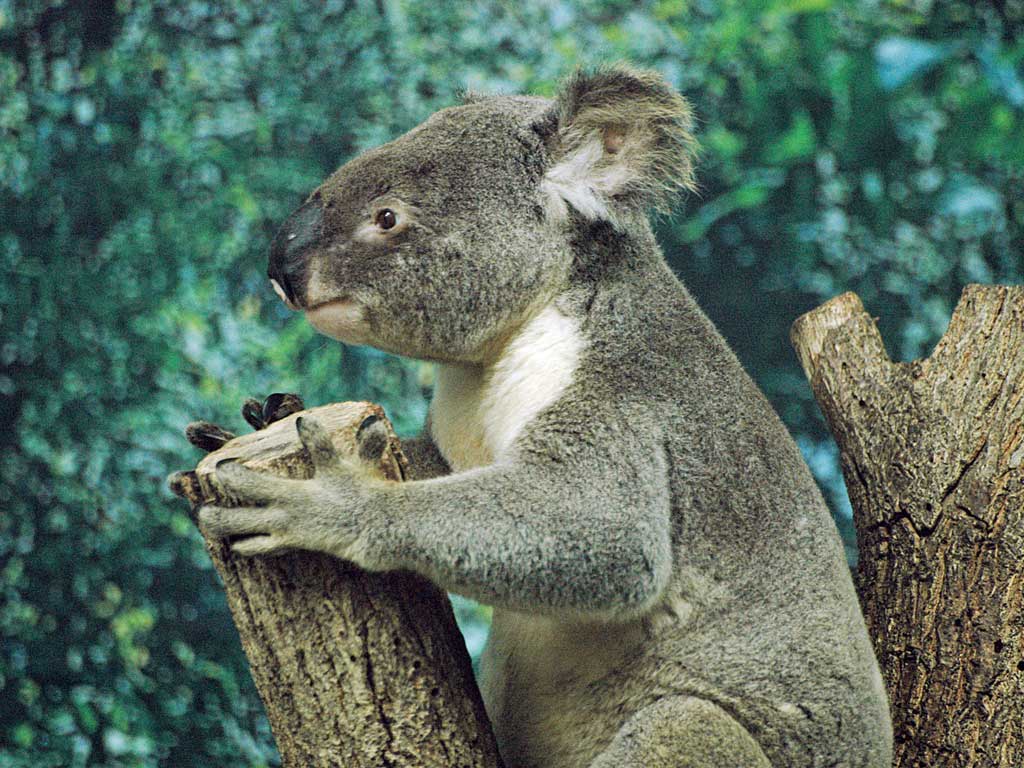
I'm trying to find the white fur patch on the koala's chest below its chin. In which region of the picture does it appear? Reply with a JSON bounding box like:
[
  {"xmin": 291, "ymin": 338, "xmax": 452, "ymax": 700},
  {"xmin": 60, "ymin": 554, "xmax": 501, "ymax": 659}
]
[{"xmin": 430, "ymin": 306, "xmax": 584, "ymax": 472}]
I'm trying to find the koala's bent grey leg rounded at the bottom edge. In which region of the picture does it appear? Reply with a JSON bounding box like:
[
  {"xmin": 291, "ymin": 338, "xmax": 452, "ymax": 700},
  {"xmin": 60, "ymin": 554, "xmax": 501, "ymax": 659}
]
[{"xmin": 590, "ymin": 696, "xmax": 771, "ymax": 768}]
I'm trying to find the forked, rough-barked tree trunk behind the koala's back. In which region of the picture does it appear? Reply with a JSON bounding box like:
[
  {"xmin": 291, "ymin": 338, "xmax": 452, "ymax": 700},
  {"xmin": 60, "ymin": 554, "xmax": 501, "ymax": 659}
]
[{"xmin": 793, "ymin": 286, "xmax": 1024, "ymax": 768}]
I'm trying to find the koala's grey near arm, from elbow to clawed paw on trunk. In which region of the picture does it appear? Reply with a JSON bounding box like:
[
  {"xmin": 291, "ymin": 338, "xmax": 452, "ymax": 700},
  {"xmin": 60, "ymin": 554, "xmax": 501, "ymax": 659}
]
[{"xmin": 200, "ymin": 420, "xmax": 672, "ymax": 618}]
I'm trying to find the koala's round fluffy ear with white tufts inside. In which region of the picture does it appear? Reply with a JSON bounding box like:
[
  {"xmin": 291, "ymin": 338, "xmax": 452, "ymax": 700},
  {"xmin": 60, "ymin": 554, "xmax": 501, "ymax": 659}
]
[{"xmin": 534, "ymin": 66, "xmax": 696, "ymax": 222}]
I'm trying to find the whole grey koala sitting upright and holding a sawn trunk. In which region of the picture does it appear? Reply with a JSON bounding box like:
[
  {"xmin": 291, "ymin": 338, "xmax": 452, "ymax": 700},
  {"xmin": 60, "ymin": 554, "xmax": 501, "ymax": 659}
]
[{"xmin": 182, "ymin": 66, "xmax": 892, "ymax": 768}]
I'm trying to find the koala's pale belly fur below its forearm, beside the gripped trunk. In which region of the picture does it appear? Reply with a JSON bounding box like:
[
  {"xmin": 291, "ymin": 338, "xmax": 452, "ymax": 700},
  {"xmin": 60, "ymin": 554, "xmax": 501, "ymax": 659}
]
[{"xmin": 480, "ymin": 609, "xmax": 642, "ymax": 768}]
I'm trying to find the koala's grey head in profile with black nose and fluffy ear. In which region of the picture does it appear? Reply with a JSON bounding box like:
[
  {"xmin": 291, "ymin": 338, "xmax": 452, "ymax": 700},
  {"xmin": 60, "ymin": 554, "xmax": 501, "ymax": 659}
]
[{"xmin": 268, "ymin": 67, "xmax": 694, "ymax": 361}]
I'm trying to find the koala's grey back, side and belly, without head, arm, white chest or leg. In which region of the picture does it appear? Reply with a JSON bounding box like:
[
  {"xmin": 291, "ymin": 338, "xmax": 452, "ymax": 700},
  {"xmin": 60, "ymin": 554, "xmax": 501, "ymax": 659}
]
[{"xmin": 484, "ymin": 257, "xmax": 892, "ymax": 768}]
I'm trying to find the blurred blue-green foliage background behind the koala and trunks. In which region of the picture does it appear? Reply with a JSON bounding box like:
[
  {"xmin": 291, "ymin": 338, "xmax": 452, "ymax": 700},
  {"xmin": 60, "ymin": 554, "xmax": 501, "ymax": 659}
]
[{"xmin": 0, "ymin": 0, "xmax": 1024, "ymax": 768}]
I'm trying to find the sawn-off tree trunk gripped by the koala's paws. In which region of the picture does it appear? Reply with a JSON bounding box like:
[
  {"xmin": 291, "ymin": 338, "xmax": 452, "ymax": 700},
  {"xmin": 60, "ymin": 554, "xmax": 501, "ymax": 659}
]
[{"xmin": 177, "ymin": 402, "xmax": 499, "ymax": 768}]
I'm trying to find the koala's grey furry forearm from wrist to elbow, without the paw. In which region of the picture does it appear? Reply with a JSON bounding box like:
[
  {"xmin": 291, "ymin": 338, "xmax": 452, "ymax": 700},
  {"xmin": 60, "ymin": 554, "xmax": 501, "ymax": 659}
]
[{"xmin": 360, "ymin": 423, "xmax": 672, "ymax": 616}]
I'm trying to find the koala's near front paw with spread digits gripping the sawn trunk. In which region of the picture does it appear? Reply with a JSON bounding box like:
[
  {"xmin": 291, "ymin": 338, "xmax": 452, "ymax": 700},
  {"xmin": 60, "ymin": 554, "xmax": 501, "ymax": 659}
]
[{"xmin": 193, "ymin": 417, "xmax": 374, "ymax": 559}]
